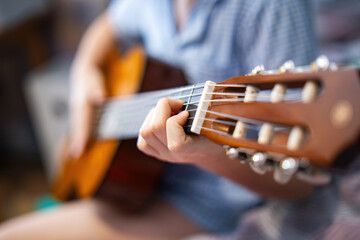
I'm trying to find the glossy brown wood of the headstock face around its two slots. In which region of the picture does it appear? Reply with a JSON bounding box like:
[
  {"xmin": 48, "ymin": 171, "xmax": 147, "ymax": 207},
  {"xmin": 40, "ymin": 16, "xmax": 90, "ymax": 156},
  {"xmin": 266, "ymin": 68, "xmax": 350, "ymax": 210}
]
[{"xmin": 201, "ymin": 69, "xmax": 360, "ymax": 166}]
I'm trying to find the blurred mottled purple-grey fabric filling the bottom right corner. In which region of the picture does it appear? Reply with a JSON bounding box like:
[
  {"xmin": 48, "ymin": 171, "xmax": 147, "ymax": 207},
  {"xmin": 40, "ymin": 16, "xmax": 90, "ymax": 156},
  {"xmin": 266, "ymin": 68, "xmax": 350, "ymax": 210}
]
[{"xmin": 188, "ymin": 155, "xmax": 360, "ymax": 240}]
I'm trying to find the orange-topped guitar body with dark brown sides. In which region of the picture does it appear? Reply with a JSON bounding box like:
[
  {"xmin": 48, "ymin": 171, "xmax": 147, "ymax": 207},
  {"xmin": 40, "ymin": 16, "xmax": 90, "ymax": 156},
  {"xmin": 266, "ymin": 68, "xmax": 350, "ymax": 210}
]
[{"xmin": 53, "ymin": 48, "xmax": 186, "ymax": 211}]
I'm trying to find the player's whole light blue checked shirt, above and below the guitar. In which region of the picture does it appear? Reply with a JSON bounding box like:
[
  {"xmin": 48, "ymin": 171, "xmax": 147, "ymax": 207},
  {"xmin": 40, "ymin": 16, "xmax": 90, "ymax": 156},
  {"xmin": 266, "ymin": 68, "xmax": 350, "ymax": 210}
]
[{"xmin": 108, "ymin": 0, "xmax": 316, "ymax": 233}]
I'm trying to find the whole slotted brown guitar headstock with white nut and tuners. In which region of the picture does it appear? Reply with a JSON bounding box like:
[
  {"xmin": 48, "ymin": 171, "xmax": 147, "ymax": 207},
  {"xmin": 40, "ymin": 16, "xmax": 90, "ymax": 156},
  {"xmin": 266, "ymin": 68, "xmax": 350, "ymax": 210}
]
[{"xmin": 192, "ymin": 56, "xmax": 360, "ymax": 183}]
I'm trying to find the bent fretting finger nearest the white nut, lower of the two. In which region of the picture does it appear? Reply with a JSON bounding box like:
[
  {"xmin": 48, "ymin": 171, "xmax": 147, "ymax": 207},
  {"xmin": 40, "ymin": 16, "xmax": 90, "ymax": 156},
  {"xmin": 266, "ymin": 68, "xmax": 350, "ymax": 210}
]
[{"xmin": 166, "ymin": 111, "xmax": 189, "ymax": 152}]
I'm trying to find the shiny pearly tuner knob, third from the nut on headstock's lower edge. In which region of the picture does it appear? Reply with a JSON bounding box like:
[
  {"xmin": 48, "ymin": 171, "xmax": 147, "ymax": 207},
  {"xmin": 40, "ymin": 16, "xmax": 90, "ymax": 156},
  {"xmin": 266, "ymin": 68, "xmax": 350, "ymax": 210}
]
[{"xmin": 274, "ymin": 157, "xmax": 299, "ymax": 184}]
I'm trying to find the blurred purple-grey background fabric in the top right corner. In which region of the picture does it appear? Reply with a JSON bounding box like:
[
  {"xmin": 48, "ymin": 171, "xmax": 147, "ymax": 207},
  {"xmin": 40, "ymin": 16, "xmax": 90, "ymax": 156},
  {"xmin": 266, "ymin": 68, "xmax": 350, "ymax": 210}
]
[{"xmin": 314, "ymin": 0, "xmax": 360, "ymax": 67}]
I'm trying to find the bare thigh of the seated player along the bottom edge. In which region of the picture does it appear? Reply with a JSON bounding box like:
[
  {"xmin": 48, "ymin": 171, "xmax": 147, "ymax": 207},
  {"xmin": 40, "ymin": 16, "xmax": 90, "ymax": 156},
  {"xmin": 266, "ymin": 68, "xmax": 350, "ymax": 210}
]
[{"xmin": 0, "ymin": 199, "xmax": 203, "ymax": 240}]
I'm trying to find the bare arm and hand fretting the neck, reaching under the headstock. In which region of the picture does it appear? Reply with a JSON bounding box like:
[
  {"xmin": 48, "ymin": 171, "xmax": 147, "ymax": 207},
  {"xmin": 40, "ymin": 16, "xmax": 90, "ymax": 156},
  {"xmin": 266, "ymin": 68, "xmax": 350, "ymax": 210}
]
[{"xmin": 138, "ymin": 99, "xmax": 313, "ymax": 200}]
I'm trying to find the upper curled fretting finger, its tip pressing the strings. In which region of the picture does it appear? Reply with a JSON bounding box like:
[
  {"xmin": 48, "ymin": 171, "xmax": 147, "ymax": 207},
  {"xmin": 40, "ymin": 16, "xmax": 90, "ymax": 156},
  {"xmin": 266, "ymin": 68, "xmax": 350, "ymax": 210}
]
[{"xmin": 150, "ymin": 98, "xmax": 183, "ymax": 143}]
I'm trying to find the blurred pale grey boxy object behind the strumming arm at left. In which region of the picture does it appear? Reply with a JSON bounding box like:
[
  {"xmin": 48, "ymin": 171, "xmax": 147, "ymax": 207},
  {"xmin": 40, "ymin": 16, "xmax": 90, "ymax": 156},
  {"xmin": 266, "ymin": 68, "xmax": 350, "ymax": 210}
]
[{"xmin": 25, "ymin": 58, "xmax": 71, "ymax": 178}]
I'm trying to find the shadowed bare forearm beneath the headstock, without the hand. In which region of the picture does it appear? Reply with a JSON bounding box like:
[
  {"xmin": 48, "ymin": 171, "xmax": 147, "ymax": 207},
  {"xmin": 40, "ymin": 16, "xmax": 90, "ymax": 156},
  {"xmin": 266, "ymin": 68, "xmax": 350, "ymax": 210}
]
[{"xmin": 193, "ymin": 146, "xmax": 313, "ymax": 200}]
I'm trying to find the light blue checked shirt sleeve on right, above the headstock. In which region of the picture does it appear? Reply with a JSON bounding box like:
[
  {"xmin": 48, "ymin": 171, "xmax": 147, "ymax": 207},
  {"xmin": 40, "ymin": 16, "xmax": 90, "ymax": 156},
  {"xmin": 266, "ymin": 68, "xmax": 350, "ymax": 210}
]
[{"xmin": 237, "ymin": 0, "xmax": 317, "ymax": 72}]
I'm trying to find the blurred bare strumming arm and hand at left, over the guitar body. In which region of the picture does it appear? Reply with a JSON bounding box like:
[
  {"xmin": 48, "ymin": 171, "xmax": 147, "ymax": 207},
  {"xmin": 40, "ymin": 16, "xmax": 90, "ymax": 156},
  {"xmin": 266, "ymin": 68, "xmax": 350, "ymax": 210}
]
[{"xmin": 70, "ymin": 13, "xmax": 115, "ymax": 157}]
